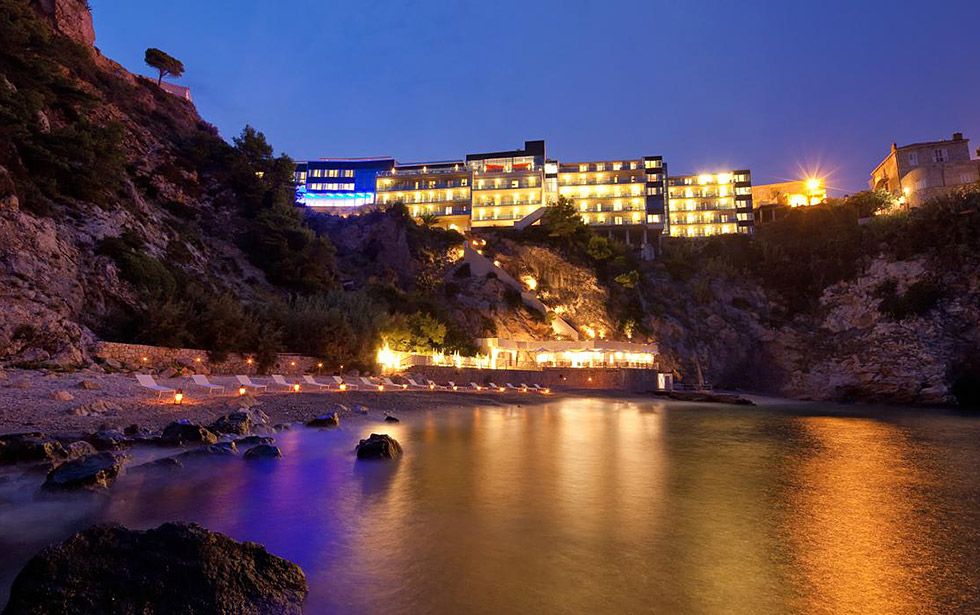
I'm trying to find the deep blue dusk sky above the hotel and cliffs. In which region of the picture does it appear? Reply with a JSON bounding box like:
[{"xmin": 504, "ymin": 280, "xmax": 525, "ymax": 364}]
[{"xmin": 91, "ymin": 0, "xmax": 980, "ymax": 191}]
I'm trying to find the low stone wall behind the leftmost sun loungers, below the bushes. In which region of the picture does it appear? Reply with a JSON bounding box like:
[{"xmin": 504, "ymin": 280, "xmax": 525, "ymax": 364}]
[{"xmin": 95, "ymin": 342, "xmax": 319, "ymax": 375}]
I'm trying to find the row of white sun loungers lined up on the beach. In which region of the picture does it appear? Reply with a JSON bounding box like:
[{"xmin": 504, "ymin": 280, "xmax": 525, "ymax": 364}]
[{"xmin": 136, "ymin": 374, "xmax": 551, "ymax": 397}]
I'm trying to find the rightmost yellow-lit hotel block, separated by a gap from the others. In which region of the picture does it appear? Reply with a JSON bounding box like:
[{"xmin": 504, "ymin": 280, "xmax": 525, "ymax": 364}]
[{"xmin": 667, "ymin": 169, "xmax": 754, "ymax": 237}]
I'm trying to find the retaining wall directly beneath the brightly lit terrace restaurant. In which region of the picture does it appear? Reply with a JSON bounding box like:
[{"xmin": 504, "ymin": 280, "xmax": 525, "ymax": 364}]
[{"xmin": 409, "ymin": 365, "xmax": 660, "ymax": 392}]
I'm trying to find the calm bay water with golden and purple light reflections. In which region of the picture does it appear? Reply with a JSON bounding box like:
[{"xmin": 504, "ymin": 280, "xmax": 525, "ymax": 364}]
[{"xmin": 0, "ymin": 399, "xmax": 980, "ymax": 613}]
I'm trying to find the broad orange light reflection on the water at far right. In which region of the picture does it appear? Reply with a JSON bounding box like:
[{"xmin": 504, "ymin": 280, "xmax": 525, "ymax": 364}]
[{"xmin": 786, "ymin": 417, "xmax": 941, "ymax": 613}]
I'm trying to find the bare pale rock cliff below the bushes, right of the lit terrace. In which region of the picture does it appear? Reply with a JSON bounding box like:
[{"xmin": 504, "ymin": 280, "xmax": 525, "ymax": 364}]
[{"xmin": 647, "ymin": 222, "xmax": 980, "ymax": 405}]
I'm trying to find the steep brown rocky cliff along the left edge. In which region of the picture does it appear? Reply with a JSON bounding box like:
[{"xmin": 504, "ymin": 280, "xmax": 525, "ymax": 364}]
[{"xmin": 0, "ymin": 0, "xmax": 272, "ymax": 365}]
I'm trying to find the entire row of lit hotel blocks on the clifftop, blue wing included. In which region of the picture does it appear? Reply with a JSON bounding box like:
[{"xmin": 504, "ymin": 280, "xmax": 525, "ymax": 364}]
[{"xmin": 296, "ymin": 141, "xmax": 752, "ymax": 241}]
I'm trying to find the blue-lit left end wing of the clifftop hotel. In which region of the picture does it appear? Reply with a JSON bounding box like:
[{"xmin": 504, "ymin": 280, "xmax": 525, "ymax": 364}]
[{"xmin": 296, "ymin": 157, "xmax": 395, "ymax": 214}]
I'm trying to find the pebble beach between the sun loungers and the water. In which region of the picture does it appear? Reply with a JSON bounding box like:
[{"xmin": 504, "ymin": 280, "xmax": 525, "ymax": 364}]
[{"xmin": 0, "ymin": 370, "xmax": 556, "ymax": 434}]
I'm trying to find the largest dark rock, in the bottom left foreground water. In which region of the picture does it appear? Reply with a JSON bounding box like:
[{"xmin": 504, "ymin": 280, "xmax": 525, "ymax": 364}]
[{"xmin": 4, "ymin": 523, "xmax": 309, "ymax": 615}]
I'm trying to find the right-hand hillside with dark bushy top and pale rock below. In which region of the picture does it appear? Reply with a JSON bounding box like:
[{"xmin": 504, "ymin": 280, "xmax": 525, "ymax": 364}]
[{"xmin": 642, "ymin": 191, "xmax": 980, "ymax": 405}]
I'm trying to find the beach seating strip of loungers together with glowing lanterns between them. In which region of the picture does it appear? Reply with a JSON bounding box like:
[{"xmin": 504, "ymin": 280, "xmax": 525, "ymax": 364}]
[{"xmin": 136, "ymin": 374, "xmax": 551, "ymax": 403}]
